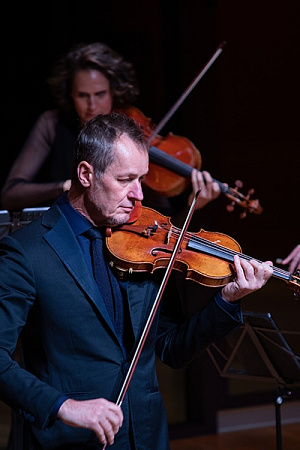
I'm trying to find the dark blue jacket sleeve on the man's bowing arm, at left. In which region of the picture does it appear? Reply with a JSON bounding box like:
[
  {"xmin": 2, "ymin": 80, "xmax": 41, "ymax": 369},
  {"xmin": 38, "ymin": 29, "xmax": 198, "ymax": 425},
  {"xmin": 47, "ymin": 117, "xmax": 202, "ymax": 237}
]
[{"xmin": 0, "ymin": 236, "xmax": 62, "ymax": 428}]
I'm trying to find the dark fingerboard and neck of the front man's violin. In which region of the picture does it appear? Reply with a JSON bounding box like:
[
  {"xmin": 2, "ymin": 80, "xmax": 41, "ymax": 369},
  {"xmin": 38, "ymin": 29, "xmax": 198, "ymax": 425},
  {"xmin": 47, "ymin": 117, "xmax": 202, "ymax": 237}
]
[{"xmin": 187, "ymin": 237, "xmax": 293, "ymax": 281}]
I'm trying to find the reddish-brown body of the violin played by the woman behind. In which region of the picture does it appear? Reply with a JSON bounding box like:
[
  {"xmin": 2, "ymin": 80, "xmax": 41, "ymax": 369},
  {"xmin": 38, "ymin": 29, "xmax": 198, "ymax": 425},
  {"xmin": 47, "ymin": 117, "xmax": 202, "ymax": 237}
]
[{"xmin": 120, "ymin": 106, "xmax": 202, "ymax": 197}]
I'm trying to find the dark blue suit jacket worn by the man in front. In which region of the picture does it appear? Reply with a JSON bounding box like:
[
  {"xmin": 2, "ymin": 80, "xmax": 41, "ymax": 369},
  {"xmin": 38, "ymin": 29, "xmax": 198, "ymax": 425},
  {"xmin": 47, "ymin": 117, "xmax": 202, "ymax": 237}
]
[{"xmin": 0, "ymin": 204, "xmax": 241, "ymax": 450}]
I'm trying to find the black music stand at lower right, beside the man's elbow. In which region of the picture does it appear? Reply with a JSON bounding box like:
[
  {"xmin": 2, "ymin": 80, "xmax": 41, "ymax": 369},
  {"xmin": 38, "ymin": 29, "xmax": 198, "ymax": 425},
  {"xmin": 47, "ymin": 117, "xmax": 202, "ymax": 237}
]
[{"xmin": 207, "ymin": 312, "xmax": 300, "ymax": 450}]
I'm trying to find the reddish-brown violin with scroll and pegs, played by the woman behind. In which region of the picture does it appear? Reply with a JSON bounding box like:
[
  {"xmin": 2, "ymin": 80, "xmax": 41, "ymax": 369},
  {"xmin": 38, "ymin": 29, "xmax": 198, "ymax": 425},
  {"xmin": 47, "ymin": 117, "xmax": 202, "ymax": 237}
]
[{"xmin": 119, "ymin": 106, "xmax": 263, "ymax": 218}]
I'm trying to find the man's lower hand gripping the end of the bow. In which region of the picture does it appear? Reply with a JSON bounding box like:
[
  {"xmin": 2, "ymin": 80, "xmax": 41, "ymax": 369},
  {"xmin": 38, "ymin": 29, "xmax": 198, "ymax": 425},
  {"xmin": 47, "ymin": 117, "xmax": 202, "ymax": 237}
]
[{"xmin": 57, "ymin": 398, "xmax": 123, "ymax": 445}]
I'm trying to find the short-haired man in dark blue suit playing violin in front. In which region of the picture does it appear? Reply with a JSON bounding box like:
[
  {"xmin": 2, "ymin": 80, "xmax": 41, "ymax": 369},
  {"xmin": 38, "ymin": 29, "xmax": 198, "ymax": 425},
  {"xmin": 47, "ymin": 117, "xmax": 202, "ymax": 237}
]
[{"xmin": 0, "ymin": 114, "xmax": 272, "ymax": 450}]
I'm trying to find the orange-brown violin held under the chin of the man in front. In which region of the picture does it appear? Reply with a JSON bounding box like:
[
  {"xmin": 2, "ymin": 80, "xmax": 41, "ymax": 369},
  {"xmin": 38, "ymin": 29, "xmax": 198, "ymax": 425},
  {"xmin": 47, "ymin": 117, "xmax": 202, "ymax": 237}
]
[{"xmin": 106, "ymin": 206, "xmax": 300, "ymax": 298}]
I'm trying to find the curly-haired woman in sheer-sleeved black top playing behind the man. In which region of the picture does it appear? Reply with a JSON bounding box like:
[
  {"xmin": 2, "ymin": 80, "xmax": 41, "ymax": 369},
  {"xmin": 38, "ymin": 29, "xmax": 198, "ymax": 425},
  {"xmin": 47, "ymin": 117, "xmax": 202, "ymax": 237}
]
[{"xmin": 1, "ymin": 42, "xmax": 220, "ymax": 225}]
